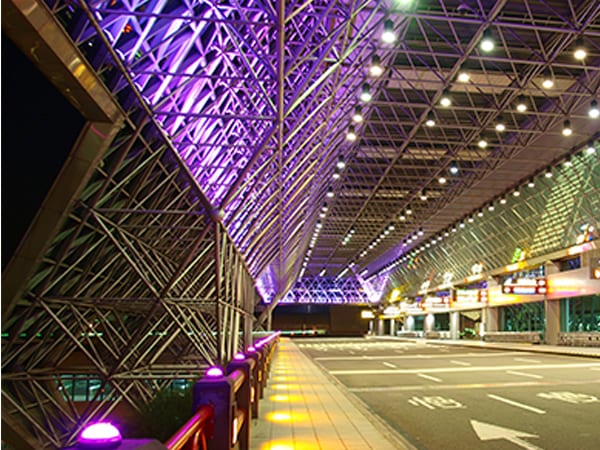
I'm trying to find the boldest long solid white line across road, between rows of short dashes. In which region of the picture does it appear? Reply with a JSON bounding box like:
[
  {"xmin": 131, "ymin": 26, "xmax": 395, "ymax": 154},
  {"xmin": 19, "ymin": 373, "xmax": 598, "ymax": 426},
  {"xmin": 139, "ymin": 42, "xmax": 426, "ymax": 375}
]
[{"xmin": 329, "ymin": 363, "xmax": 600, "ymax": 375}]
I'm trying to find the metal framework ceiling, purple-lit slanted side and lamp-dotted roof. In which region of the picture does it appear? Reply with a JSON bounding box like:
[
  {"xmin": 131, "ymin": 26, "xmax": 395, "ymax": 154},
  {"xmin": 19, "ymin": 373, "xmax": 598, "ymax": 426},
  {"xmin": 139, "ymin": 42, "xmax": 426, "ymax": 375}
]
[{"xmin": 55, "ymin": 0, "xmax": 600, "ymax": 299}]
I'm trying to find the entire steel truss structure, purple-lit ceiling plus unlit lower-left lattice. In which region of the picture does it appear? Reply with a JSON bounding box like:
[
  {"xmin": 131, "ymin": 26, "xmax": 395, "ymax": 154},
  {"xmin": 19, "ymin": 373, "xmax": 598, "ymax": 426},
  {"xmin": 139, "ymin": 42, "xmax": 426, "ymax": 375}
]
[{"xmin": 2, "ymin": 0, "xmax": 600, "ymax": 448}]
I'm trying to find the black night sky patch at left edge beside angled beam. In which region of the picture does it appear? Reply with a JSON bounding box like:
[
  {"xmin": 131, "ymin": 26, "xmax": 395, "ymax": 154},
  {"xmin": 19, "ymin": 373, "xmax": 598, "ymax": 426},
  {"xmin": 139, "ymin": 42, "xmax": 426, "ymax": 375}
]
[{"xmin": 1, "ymin": 33, "xmax": 84, "ymax": 270}]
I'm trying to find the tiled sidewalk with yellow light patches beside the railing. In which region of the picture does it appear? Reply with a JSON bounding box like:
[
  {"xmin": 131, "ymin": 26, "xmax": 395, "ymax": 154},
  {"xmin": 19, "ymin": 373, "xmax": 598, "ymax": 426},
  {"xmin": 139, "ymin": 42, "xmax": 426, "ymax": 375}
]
[{"xmin": 250, "ymin": 338, "xmax": 412, "ymax": 450}]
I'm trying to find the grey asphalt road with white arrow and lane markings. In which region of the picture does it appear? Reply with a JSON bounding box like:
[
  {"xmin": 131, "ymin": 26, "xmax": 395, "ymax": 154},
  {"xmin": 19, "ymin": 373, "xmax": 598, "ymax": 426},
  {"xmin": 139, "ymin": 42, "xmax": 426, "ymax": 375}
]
[{"xmin": 297, "ymin": 339, "xmax": 600, "ymax": 450}]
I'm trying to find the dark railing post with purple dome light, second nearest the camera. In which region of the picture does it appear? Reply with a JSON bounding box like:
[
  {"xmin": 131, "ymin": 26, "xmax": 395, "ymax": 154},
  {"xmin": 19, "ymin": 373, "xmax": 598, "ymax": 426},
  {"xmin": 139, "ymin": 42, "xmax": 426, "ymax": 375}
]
[{"xmin": 193, "ymin": 367, "xmax": 236, "ymax": 450}]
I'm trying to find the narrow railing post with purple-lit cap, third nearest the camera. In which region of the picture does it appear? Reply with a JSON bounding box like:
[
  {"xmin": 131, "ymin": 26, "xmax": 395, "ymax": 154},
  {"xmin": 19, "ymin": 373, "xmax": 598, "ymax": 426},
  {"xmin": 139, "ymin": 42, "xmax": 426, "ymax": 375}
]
[{"xmin": 226, "ymin": 353, "xmax": 253, "ymax": 449}]
